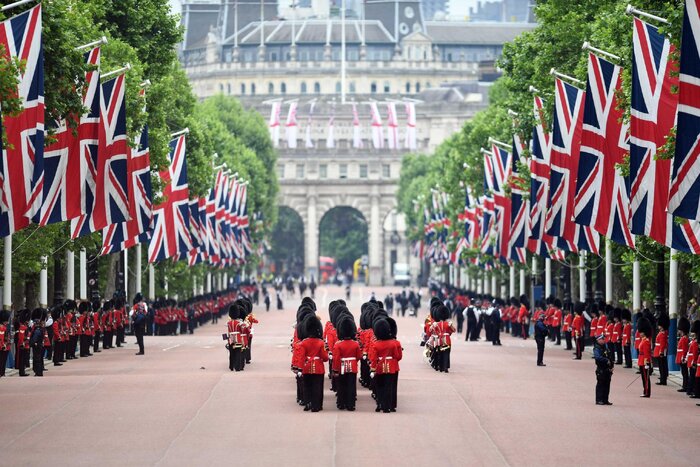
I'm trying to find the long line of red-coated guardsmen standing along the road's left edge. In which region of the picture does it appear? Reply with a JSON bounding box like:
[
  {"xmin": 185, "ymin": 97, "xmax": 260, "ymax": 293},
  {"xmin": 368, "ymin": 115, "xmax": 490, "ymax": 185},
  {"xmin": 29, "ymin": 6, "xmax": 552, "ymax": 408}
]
[{"xmin": 0, "ymin": 290, "xmax": 241, "ymax": 377}]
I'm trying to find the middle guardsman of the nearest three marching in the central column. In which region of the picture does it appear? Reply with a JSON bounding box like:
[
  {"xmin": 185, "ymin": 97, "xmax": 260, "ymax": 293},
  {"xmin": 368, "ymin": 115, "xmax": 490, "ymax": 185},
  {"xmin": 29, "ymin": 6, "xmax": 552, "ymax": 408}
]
[{"xmin": 333, "ymin": 313, "xmax": 362, "ymax": 412}]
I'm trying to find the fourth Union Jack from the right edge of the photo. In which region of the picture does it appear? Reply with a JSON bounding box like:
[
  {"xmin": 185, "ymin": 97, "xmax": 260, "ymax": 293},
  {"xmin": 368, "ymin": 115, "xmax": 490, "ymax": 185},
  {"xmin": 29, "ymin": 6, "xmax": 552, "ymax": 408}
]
[{"xmin": 546, "ymin": 79, "xmax": 600, "ymax": 254}]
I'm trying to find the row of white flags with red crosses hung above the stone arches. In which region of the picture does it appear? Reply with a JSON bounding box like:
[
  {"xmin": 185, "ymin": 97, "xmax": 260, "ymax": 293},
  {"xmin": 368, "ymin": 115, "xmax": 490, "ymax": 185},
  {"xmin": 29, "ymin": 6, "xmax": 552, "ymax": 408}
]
[{"xmin": 268, "ymin": 101, "xmax": 418, "ymax": 151}]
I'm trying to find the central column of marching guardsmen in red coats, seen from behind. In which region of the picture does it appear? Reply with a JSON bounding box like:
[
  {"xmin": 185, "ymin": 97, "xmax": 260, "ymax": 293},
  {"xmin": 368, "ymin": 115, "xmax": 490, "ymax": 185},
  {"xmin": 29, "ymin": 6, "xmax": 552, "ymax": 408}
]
[{"xmin": 291, "ymin": 297, "xmax": 403, "ymax": 413}]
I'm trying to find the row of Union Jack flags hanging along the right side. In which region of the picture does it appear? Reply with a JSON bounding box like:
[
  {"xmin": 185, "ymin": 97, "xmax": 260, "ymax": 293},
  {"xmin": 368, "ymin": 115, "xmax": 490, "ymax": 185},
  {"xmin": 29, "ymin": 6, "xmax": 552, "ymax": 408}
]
[{"xmin": 420, "ymin": 1, "xmax": 700, "ymax": 268}]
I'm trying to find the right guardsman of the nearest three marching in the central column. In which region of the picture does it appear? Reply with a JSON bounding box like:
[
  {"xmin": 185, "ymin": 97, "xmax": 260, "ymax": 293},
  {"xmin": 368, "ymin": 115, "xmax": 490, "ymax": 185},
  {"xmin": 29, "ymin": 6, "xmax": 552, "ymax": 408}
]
[{"xmin": 370, "ymin": 319, "xmax": 403, "ymax": 413}]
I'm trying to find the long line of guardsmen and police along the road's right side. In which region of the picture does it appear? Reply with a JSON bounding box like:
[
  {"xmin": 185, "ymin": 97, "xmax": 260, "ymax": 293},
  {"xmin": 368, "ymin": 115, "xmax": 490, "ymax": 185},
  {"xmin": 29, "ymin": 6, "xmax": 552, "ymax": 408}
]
[{"xmin": 421, "ymin": 286, "xmax": 700, "ymax": 405}]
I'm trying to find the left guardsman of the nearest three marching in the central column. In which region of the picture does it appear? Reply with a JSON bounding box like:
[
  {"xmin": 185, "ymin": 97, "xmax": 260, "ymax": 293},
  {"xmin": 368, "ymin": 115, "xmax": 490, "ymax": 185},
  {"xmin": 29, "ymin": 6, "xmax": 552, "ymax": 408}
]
[{"xmin": 299, "ymin": 315, "xmax": 328, "ymax": 412}]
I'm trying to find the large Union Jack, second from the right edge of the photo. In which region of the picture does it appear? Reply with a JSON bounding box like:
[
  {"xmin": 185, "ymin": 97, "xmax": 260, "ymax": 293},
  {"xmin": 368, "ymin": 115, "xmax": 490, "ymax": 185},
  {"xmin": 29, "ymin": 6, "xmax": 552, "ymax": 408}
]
[{"xmin": 630, "ymin": 18, "xmax": 700, "ymax": 253}]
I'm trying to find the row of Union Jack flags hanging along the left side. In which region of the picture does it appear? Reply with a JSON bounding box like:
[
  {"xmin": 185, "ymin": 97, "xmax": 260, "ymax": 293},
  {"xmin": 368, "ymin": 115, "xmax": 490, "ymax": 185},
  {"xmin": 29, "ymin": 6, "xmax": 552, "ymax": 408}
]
[{"xmin": 0, "ymin": 5, "xmax": 253, "ymax": 266}]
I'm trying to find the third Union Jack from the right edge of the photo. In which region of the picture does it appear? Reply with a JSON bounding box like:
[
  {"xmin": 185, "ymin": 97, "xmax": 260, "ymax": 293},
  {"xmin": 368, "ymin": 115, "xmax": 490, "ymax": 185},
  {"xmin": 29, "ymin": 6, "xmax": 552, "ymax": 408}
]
[{"xmin": 574, "ymin": 54, "xmax": 634, "ymax": 248}]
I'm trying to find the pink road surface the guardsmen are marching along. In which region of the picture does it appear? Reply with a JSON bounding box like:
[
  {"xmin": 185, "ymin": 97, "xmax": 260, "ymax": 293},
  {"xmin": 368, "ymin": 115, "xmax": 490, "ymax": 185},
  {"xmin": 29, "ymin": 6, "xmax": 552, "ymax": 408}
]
[{"xmin": 0, "ymin": 286, "xmax": 700, "ymax": 467}]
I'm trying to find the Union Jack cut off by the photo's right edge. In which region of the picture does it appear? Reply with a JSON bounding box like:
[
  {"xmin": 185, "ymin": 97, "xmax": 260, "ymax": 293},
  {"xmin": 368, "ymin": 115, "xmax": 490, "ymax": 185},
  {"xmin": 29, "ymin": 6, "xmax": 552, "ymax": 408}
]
[{"xmin": 668, "ymin": 0, "xmax": 700, "ymax": 220}]
